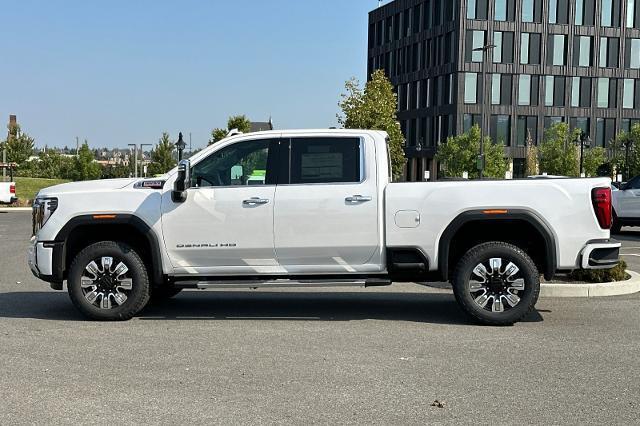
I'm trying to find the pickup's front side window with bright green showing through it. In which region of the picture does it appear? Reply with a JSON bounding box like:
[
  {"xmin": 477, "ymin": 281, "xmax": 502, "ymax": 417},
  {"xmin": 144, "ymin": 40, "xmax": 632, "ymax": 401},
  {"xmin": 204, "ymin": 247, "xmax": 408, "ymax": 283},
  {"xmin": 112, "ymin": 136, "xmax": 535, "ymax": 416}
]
[{"xmin": 191, "ymin": 139, "xmax": 275, "ymax": 188}]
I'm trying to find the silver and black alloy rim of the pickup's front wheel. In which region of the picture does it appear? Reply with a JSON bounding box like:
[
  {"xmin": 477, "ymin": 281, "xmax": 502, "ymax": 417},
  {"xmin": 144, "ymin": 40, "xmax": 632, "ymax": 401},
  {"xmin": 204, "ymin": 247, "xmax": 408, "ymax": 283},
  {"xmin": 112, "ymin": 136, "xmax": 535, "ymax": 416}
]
[{"xmin": 80, "ymin": 256, "xmax": 133, "ymax": 309}]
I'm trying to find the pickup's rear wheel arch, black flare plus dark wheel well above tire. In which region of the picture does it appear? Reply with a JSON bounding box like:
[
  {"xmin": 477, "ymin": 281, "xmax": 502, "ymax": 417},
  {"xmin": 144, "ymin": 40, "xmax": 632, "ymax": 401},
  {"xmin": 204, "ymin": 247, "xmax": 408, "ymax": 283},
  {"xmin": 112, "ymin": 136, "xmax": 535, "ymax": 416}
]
[{"xmin": 438, "ymin": 208, "xmax": 557, "ymax": 281}]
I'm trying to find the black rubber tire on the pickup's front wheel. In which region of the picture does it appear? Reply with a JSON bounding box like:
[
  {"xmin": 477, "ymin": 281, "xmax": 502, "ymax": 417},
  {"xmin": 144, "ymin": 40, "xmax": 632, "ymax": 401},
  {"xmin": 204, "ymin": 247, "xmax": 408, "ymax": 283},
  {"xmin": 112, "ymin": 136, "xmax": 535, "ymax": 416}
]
[{"xmin": 67, "ymin": 241, "xmax": 150, "ymax": 321}]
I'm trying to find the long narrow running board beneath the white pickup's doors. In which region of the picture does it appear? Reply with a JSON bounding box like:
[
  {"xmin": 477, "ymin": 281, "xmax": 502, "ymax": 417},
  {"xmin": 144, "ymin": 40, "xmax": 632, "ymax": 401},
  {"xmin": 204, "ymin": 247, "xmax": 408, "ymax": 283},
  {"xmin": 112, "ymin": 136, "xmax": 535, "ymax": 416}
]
[{"xmin": 174, "ymin": 278, "xmax": 391, "ymax": 290}]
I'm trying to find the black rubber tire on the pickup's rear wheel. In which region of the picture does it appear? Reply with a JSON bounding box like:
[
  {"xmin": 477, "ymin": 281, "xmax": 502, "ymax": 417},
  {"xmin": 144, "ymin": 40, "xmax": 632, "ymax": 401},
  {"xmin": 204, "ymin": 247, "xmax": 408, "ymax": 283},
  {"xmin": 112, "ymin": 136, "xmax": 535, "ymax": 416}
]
[{"xmin": 452, "ymin": 242, "xmax": 540, "ymax": 326}]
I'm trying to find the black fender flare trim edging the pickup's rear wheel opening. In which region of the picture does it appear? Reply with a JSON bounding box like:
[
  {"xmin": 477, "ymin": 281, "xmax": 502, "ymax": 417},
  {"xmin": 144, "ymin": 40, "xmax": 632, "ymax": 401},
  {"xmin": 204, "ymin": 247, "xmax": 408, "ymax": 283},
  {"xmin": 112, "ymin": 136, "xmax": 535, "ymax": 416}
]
[{"xmin": 438, "ymin": 208, "xmax": 558, "ymax": 281}]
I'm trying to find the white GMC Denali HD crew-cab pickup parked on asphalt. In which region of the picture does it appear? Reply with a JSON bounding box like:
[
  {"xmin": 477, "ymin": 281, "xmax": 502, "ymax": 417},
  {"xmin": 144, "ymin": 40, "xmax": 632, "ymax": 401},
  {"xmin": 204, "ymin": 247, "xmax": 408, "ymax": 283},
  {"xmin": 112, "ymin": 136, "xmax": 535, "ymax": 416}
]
[{"xmin": 29, "ymin": 130, "xmax": 620, "ymax": 325}]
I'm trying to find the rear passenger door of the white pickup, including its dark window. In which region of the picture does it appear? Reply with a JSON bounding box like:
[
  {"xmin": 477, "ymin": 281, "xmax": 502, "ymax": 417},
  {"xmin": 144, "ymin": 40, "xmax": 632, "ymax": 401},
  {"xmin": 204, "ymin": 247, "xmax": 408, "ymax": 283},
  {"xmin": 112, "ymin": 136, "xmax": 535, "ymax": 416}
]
[{"xmin": 274, "ymin": 136, "xmax": 381, "ymax": 273}]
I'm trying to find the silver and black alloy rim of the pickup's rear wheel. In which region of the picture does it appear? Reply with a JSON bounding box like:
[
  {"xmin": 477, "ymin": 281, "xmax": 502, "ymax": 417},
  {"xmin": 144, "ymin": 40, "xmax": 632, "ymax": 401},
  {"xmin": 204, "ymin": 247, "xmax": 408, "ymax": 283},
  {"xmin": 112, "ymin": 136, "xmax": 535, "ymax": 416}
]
[{"xmin": 469, "ymin": 257, "xmax": 525, "ymax": 312}]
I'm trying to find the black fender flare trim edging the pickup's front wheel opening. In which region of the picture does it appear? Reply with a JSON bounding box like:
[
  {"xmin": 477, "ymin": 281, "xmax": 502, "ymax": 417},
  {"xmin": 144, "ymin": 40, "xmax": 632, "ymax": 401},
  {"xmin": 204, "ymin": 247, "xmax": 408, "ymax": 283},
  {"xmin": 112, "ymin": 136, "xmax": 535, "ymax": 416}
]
[{"xmin": 53, "ymin": 213, "xmax": 164, "ymax": 283}]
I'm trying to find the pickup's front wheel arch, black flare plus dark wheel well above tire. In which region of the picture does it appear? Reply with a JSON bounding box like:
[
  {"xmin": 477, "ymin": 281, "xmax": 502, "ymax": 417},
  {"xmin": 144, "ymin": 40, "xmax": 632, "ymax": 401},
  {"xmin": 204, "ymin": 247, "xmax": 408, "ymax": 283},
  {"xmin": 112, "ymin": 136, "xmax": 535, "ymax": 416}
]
[{"xmin": 54, "ymin": 213, "xmax": 163, "ymax": 284}]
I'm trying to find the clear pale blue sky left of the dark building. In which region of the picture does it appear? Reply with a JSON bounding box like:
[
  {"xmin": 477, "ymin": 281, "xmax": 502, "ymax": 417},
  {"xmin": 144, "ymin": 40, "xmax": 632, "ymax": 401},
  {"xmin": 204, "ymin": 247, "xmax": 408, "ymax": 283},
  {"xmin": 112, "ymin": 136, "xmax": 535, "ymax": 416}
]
[{"xmin": 0, "ymin": 0, "xmax": 377, "ymax": 149}]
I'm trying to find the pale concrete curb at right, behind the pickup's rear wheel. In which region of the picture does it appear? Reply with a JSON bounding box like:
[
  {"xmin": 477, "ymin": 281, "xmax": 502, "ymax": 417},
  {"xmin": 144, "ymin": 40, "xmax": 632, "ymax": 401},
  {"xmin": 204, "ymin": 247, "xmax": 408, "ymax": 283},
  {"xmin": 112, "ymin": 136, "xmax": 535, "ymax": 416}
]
[{"xmin": 540, "ymin": 271, "xmax": 640, "ymax": 297}]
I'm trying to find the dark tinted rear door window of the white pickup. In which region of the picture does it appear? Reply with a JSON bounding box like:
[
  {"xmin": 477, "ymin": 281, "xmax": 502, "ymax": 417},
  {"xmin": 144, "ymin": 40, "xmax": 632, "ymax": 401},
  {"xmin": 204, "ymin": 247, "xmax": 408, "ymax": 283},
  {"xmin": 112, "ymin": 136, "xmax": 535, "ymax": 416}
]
[{"xmin": 290, "ymin": 138, "xmax": 361, "ymax": 184}]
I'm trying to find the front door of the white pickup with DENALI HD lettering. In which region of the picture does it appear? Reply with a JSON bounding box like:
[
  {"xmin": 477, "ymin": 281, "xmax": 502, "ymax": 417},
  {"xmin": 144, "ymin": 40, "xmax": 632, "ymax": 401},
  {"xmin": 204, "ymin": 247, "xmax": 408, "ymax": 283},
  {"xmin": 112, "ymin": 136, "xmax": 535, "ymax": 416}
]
[{"xmin": 162, "ymin": 139, "xmax": 278, "ymax": 275}]
